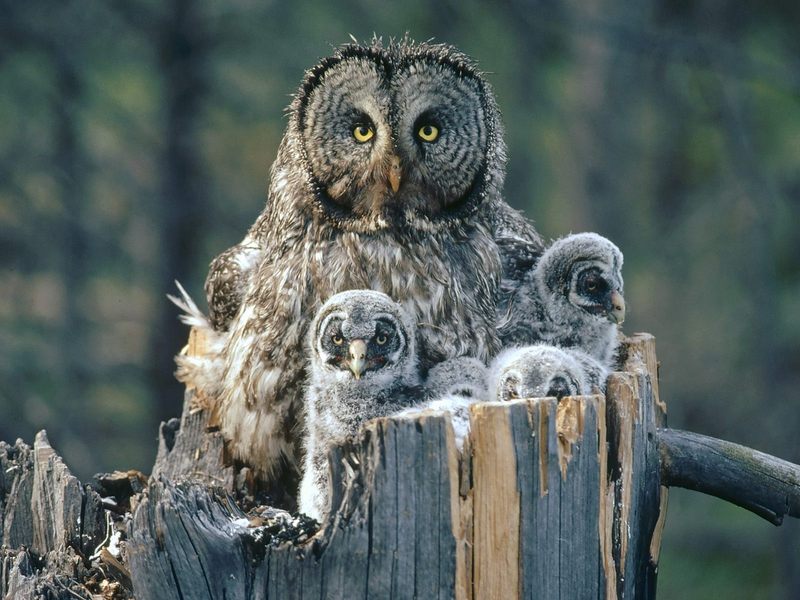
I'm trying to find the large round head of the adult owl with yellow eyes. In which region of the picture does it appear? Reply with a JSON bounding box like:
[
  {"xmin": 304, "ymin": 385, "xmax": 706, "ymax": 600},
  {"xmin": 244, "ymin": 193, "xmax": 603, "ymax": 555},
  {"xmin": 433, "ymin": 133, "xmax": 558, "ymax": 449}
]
[{"xmin": 287, "ymin": 39, "xmax": 505, "ymax": 232}]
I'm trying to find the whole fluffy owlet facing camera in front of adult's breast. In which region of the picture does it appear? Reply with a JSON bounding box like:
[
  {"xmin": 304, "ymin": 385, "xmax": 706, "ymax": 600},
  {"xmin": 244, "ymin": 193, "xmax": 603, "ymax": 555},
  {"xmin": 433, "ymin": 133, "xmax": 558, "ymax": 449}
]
[{"xmin": 299, "ymin": 290, "xmax": 422, "ymax": 521}]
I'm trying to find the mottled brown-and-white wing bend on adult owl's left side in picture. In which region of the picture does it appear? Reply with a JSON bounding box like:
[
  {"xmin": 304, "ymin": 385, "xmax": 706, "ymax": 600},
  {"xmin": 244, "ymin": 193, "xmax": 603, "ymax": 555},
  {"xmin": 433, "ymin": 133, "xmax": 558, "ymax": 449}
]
[{"xmin": 205, "ymin": 238, "xmax": 263, "ymax": 331}]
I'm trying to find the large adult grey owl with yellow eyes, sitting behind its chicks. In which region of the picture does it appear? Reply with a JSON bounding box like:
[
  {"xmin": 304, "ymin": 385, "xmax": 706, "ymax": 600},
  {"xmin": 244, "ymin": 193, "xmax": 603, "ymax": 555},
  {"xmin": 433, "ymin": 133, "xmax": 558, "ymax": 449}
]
[{"xmin": 176, "ymin": 40, "xmax": 530, "ymax": 488}]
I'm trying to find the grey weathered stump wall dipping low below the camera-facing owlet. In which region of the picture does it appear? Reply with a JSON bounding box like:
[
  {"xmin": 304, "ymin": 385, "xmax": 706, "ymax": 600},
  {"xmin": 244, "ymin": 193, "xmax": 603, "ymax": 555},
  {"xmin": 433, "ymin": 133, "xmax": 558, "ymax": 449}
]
[{"xmin": 129, "ymin": 416, "xmax": 463, "ymax": 600}]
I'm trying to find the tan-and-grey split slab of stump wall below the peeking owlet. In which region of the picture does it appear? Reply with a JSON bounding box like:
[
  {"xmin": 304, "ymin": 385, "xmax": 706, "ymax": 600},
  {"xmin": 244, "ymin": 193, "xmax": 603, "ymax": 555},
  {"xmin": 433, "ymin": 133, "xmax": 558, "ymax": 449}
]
[{"xmin": 472, "ymin": 396, "xmax": 614, "ymax": 598}]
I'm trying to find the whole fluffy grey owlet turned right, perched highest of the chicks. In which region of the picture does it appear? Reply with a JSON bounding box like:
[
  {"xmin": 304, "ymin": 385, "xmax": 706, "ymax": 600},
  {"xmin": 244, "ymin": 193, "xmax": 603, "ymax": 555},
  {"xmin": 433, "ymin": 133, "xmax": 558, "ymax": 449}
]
[{"xmin": 498, "ymin": 233, "xmax": 625, "ymax": 368}]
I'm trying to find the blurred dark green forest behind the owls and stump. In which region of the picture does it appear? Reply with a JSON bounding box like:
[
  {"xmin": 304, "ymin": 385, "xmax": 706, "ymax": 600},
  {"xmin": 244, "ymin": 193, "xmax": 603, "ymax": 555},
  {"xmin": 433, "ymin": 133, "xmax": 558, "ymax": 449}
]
[{"xmin": 0, "ymin": 0, "xmax": 800, "ymax": 599}]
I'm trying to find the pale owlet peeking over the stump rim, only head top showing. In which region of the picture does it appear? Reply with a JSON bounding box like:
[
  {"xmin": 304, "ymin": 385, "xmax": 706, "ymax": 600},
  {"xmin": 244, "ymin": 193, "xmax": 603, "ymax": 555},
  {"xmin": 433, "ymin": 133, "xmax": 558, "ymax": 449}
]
[{"xmin": 489, "ymin": 344, "xmax": 608, "ymax": 401}]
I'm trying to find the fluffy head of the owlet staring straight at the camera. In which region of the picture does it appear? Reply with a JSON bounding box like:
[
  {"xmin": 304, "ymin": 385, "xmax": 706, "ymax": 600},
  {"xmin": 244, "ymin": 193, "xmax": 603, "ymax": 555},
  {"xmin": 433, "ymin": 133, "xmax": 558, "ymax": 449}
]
[{"xmin": 310, "ymin": 290, "xmax": 417, "ymax": 383}]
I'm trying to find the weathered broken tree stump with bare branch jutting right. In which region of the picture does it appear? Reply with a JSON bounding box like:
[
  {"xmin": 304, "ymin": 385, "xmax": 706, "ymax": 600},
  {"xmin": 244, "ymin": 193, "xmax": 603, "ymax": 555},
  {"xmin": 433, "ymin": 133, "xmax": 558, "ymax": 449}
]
[{"xmin": 0, "ymin": 335, "xmax": 800, "ymax": 600}]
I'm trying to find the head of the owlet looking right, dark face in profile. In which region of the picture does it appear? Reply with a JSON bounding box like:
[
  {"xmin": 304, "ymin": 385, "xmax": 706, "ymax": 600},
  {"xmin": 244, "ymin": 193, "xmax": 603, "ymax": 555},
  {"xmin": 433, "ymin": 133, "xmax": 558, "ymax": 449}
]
[{"xmin": 536, "ymin": 233, "xmax": 625, "ymax": 323}]
